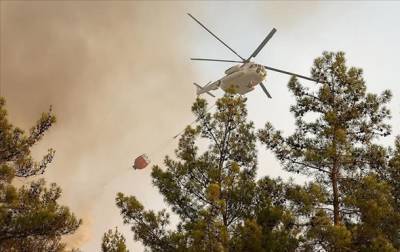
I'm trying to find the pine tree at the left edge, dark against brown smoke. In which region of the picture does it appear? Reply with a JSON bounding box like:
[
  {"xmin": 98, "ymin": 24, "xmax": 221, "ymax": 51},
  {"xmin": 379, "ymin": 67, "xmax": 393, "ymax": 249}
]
[{"xmin": 0, "ymin": 98, "xmax": 81, "ymax": 251}]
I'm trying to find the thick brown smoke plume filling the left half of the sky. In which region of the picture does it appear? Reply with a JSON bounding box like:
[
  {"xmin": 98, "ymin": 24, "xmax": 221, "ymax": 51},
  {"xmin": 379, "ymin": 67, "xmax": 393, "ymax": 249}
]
[{"xmin": 0, "ymin": 1, "xmax": 202, "ymax": 250}]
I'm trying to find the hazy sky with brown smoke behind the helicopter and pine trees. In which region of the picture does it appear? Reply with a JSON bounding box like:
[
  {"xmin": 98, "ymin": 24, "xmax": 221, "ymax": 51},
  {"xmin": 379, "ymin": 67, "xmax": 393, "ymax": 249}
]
[{"xmin": 0, "ymin": 1, "xmax": 400, "ymax": 251}]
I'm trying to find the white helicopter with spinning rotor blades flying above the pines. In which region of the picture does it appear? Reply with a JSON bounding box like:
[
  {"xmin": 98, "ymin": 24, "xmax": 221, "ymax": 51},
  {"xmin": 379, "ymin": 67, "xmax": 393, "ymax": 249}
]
[{"xmin": 188, "ymin": 13, "xmax": 323, "ymax": 98}]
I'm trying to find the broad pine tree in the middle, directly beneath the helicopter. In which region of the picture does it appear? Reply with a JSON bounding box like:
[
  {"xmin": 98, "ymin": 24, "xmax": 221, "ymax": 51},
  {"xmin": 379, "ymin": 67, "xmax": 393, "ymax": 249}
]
[{"xmin": 116, "ymin": 94, "xmax": 298, "ymax": 252}]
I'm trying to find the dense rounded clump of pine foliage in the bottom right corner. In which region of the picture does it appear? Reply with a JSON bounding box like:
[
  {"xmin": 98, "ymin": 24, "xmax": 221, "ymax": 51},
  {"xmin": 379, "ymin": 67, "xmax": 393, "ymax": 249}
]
[{"xmin": 344, "ymin": 174, "xmax": 400, "ymax": 251}]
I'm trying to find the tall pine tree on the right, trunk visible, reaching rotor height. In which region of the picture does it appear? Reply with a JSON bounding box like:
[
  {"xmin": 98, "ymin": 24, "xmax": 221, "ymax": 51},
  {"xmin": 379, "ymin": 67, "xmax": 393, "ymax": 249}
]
[{"xmin": 258, "ymin": 52, "xmax": 400, "ymax": 251}]
